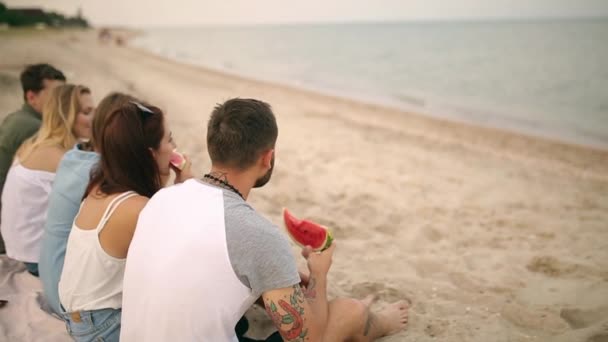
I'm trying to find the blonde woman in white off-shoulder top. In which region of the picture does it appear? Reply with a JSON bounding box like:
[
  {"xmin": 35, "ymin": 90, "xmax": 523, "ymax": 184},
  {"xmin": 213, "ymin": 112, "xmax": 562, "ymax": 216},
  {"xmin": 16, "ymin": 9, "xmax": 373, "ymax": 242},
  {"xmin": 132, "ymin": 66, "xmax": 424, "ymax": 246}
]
[{"xmin": 0, "ymin": 84, "xmax": 94, "ymax": 276}]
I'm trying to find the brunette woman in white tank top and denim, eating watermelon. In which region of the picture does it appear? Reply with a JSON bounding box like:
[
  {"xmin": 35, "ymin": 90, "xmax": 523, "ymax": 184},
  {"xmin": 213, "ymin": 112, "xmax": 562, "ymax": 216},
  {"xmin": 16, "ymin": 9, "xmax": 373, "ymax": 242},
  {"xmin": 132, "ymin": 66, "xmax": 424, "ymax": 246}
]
[{"xmin": 58, "ymin": 101, "xmax": 191, "ymax": 341}]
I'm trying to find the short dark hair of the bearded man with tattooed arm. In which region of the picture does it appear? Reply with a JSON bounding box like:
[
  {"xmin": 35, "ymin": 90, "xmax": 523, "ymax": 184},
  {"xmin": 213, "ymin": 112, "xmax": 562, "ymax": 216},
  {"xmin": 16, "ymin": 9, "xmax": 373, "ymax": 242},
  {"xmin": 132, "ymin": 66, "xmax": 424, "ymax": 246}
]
[{"xmin": 207, "ymin": 98, "xmax": 279, "ymax": 170}]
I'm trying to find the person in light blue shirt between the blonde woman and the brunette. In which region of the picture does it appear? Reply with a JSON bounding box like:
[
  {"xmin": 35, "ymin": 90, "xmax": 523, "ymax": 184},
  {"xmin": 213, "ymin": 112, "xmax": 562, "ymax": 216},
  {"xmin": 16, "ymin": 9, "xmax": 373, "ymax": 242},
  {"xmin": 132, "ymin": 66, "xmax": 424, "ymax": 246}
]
[{"xmin": 38, "ymin": 93, "xmax": 135, "ymax": 315}]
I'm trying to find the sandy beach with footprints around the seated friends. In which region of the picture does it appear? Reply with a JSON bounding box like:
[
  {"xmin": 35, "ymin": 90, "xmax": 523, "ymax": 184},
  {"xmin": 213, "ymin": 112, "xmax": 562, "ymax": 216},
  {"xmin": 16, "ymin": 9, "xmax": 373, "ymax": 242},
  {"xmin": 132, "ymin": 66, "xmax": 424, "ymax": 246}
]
[{"xmin": 0, "ymin": 31, "xmax": 608, "ymax": 342}]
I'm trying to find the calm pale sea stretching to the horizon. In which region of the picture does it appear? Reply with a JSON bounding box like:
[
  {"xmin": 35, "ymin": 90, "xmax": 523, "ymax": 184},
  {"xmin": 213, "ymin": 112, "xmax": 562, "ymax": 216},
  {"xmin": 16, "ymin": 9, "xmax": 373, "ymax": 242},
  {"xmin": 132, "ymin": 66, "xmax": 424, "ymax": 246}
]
[{"xmin": 134, "ymin": 19, "xmax": 608, "ymax": 148}]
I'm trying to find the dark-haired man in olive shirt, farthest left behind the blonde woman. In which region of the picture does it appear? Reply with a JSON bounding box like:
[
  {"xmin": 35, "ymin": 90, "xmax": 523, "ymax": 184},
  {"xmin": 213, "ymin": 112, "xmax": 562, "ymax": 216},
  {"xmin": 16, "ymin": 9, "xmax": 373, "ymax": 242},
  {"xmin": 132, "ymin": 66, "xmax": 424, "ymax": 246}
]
[{"xmin": 0, "ymin": 64, "xmax": 65, "ymax": 254}]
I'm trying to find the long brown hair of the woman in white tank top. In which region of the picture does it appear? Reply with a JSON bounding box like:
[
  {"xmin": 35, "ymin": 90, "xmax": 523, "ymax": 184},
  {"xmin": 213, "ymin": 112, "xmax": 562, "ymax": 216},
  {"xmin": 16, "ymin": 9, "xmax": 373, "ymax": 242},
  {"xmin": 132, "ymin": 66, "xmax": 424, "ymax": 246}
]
[{"xmin": 85, "ymin": 102, "xmax": 165, "ymax": 197}]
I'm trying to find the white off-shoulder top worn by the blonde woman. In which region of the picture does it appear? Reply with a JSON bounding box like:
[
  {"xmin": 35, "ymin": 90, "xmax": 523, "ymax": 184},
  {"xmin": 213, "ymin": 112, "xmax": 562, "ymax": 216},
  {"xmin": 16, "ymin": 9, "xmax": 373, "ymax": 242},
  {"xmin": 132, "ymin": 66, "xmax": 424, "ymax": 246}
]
[{"xmin": 0, "ymin": 162, "xmax": 55, "ymax": 263}]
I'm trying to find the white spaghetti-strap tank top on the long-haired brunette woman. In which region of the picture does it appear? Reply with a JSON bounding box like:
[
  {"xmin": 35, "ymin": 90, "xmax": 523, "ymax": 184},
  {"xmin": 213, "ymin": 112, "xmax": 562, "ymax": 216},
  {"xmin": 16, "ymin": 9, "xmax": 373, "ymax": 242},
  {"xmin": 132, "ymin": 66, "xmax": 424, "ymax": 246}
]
[{"xmin": 59, "ymin": 191, "xmax": 137, "ymax": 312}]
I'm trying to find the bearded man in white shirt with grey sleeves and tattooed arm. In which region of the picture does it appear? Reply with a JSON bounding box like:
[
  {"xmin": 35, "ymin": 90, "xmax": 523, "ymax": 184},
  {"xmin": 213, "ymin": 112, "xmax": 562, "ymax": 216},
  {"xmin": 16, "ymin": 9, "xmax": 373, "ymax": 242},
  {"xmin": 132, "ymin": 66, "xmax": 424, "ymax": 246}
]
[{"xmin": 121, "ymin": 99, "xmax": 408, "ymax": 342}]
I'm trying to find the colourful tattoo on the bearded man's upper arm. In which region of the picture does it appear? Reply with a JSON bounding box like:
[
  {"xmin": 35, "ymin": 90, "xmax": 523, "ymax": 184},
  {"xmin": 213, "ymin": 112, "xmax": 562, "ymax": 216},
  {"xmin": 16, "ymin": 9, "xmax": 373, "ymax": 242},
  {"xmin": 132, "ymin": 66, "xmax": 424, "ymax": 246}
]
[{"xmin": 265, "ymin": 285, "xmax": 308, "ymax": 342}]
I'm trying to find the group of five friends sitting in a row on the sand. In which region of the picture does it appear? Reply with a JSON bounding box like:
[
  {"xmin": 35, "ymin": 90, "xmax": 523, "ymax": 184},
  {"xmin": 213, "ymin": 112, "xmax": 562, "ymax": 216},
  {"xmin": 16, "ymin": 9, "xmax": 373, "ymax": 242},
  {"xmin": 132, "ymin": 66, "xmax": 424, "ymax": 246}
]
[{"xmin": 0, "ymin": 64, "xmax": 408, "ymax": 342}]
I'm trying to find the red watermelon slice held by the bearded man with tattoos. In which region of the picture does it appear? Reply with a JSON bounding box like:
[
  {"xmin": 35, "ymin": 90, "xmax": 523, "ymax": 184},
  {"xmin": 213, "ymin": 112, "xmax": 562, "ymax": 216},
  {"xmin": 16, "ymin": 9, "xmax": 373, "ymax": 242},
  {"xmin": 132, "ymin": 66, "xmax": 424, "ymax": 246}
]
[{"xmin": 283, "ymin": 208, "xmax": 334, "ymax": 252}]
